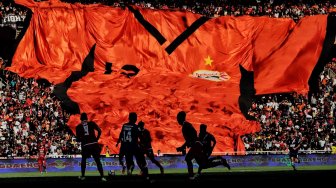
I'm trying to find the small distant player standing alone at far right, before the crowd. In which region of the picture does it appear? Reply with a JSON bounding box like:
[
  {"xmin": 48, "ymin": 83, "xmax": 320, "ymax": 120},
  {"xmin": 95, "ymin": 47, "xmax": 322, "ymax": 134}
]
[{"xmin": 287, "ymin": 131, "xmax": 301, "ymax": 170}]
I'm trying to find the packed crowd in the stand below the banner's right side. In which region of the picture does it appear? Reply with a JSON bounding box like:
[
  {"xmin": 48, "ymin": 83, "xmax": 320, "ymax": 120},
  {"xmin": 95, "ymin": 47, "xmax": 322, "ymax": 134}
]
[{"xmin": 243, "ymin": 59, "xmax": 336, "ymax": 152}]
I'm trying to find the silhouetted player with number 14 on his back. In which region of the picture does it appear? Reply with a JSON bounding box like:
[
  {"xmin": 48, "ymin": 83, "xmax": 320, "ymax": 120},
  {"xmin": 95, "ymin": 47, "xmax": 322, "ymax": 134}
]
[{"xmin": 119, "ymin": 112, "xmax": 149, "ymax": 180}]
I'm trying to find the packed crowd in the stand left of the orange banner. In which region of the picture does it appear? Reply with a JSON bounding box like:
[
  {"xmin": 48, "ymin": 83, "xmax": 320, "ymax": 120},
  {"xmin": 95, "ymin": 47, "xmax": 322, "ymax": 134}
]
[{"xmin": 0, "ymin": 60, "xmax": 80, "ymax": 158}]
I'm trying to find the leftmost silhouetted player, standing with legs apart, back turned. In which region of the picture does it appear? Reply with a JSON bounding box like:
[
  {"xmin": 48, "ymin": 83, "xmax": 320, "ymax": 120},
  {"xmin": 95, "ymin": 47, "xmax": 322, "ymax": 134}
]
[{"xmin": 76, "ymin": 113, "xmax": 106, "ymax": 181}]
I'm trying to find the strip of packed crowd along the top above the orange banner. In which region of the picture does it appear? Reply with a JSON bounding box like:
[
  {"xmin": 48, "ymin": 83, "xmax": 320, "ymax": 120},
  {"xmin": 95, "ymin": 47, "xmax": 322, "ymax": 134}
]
[{"xmin": 62, "ymin": 0, "xmax": 336, "ymax": 21}]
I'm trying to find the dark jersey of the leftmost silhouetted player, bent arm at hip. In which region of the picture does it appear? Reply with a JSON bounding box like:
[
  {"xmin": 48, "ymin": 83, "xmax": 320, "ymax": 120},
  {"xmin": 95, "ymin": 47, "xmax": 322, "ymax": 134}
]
[{"xmin": 76, "ymin": 121, "xmax": 101, "ymax": 146}]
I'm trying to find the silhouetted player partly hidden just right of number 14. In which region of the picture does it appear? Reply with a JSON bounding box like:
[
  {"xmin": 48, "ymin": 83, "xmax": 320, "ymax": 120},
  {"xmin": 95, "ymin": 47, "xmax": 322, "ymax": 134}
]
[{"xmin": 138, "ymin": 121, "xmax": 164, "ymax": 174}]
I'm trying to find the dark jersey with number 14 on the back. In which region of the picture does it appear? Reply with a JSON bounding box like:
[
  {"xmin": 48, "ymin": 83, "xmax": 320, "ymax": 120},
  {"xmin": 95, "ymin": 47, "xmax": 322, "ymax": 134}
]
[{"xmin": 119, "ymin": 123, "xmax": 139, "ymax": 146}]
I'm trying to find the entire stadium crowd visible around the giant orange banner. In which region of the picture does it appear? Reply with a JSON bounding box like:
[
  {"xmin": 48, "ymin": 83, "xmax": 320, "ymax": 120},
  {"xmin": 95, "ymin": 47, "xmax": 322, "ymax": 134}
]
[{"xmin": 0, "ymin": 0, "xmax": 336, "ymax": 158}]
